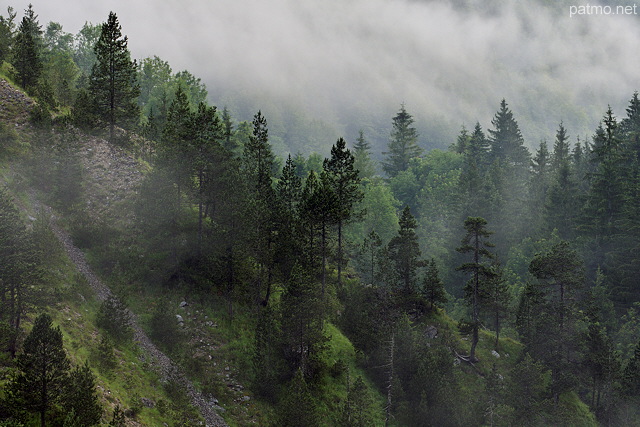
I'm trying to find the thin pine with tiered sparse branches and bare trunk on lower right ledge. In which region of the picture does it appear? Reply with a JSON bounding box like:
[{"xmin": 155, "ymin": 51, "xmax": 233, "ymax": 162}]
[{"xmin": 457, "ymin": 217, "xmax": 495, "ymax": 362}]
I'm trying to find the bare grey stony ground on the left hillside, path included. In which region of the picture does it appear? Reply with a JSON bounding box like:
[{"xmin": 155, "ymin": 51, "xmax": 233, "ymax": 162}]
[{"xmin": 0, "ymin": 79, "xmax": 227, "ymax": 426}]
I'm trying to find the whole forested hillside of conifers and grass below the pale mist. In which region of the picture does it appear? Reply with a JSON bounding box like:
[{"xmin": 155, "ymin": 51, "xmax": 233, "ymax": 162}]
[{"xmin": 0, "ymin": 2, "xmax": 640, "ymax": 427}]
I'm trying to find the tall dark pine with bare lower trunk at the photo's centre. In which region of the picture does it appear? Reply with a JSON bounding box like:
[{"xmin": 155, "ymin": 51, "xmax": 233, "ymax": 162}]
[{"xmin": 323, "ymin": 138, "xmax": 364, "ymax": 284}]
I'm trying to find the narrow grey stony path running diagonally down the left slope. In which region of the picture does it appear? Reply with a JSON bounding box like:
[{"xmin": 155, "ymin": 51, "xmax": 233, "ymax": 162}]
[{"xmin": 51, "ymin": 212, "xmax": 227, "ymax": 427}]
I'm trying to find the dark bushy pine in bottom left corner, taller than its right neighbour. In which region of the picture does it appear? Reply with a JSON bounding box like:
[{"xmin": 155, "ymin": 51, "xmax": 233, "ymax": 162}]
[{"xmin": 8, "ymin": 314, "xmax": 70, "ymax": 427}]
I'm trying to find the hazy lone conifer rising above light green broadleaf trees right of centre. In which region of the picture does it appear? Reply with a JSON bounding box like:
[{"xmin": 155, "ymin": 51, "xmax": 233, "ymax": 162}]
[{"xmin": 382, "ymin": 104, "xmax": 422, "ymax": 178}]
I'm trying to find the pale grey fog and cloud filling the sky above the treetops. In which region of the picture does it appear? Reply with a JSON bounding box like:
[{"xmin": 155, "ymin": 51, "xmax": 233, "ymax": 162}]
[{"xmin": 13, "ymin": 0, "xmax": 640, "ymax": 149}]
